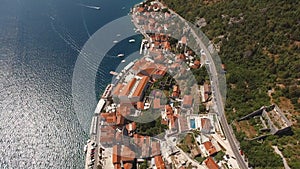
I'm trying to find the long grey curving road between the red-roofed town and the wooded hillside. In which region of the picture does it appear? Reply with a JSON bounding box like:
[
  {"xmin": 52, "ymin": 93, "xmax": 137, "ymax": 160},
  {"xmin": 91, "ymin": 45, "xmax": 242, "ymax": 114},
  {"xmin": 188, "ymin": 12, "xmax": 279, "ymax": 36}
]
[{"xmin": 164, "ymin": 4, "xmax": 248, "ymax": 169}]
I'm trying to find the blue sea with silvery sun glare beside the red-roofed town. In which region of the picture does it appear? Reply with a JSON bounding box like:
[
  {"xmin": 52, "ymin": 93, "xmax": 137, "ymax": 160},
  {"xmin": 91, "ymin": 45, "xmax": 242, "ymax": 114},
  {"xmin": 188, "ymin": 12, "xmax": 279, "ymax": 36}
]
[{"xmin": 0, "ymin": 0, "xmax": 141, "ymax": 169}]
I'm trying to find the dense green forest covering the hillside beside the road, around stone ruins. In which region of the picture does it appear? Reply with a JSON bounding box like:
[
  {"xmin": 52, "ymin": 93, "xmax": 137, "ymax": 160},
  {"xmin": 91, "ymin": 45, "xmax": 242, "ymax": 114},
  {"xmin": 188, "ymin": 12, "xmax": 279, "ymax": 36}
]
[{"xmin": 163, "ymin": 0, "xmax": 300, "ymax": 169}]
